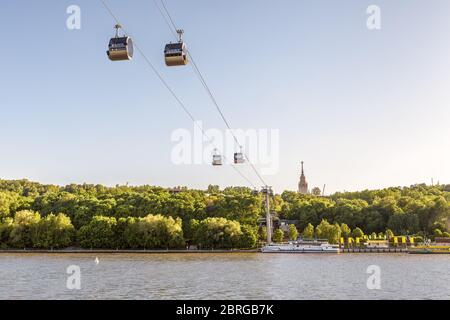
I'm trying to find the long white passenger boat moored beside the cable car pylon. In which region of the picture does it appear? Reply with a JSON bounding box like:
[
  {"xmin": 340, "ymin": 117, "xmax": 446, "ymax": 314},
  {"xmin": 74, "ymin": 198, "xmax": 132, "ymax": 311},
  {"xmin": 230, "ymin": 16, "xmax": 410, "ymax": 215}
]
[{"xmin": 261, "ymin": 240, "xmax": 340, "ymax": 253}]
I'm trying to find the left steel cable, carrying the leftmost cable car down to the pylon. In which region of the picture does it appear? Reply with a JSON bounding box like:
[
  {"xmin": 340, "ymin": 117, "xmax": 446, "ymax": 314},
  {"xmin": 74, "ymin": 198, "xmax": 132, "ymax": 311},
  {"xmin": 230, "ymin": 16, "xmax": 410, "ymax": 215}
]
[{"xmin": 100, "ymin": 0, "xmax": 256, "ymax": 188}]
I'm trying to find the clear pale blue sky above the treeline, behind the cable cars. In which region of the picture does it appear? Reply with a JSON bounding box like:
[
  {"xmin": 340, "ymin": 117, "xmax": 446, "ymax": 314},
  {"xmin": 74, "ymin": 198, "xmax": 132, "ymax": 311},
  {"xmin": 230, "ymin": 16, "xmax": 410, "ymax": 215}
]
[{"xmin": 0, "ymin": 0, "xmax": 450, "ymax": 192}]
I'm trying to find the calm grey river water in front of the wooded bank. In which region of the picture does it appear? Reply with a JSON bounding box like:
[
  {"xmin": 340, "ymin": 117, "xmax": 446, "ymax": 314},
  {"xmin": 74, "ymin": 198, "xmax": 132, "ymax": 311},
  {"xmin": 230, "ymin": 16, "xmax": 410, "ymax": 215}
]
[{"xmin": 0, "ymin": 253, "xmax": 450, "ymax": 300}]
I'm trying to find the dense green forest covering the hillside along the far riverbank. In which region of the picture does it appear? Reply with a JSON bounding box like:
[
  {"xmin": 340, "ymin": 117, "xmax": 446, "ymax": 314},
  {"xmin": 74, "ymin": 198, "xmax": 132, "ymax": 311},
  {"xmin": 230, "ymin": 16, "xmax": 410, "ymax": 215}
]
[{"xmin": 0, "ymin": 180, "xmax": 450, "ymax": 249}]
